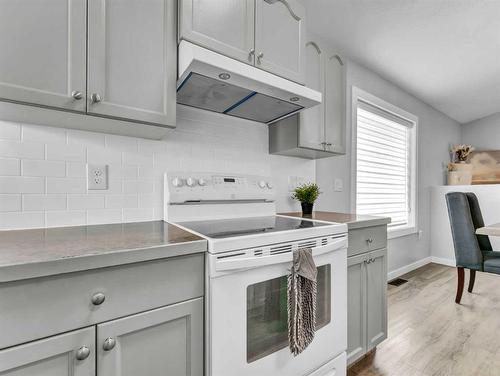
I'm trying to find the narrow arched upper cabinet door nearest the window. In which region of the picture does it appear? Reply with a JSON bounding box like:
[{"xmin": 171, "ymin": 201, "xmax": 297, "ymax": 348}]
[{"xmin": 323, "ymin": 52, "xmax": 345, "ymax": 153}]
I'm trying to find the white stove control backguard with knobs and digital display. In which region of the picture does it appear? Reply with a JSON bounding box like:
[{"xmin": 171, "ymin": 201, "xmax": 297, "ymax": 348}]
[{"xmin": 165, "ymin": 172, "xmax": 275, "ymax": 204}]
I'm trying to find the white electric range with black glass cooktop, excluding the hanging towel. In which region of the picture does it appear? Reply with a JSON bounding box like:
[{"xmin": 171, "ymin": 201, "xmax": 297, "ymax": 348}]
[{"xmin": 164, "ymin": 172, "xmax": 347, "ymax": 376}]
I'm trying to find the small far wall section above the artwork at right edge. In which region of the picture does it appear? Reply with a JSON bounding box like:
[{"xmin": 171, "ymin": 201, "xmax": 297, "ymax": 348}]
[{"xmin": 462, "ymin": 112, "xmax": 500, "ymax": 150}]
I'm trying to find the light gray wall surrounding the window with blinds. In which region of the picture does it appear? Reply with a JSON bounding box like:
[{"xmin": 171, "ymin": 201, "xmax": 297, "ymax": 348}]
[{"xmin": 316, "ymin": 61, "xmax": 461, "ymax": 271}]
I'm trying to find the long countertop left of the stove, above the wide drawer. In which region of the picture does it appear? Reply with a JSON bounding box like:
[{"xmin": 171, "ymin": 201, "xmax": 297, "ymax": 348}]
[{"xmin": 0, "ymin": 221, "xmax": 207, "ymax": 282}]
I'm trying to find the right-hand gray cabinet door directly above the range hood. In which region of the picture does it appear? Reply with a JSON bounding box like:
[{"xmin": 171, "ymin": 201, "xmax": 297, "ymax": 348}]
[{"xmin": 255, "ymin": 0, "xmax": 305, "ymax": 83}]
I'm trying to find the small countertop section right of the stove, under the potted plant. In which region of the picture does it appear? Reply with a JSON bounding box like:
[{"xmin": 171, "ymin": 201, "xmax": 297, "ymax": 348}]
[{"xmin": 279, "ymin": 211, "xmax": 391, "ymax": 230}]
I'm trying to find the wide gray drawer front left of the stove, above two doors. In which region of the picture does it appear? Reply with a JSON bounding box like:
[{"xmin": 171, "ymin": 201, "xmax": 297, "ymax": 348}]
[{"xmin": 0, "ymin": 254, "xmax": 204, "ymax": 349}]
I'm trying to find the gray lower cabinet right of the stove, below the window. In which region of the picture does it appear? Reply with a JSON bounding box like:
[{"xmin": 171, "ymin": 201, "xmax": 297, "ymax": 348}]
[{"xmin": 347, "ymin": 226, "xmax": 387, "ymax": 364}]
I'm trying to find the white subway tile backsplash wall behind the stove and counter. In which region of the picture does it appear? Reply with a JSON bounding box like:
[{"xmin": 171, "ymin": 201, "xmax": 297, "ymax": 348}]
[{"xmin": 0, "ymin": 106, "xmax": 315, "ymax": 229}]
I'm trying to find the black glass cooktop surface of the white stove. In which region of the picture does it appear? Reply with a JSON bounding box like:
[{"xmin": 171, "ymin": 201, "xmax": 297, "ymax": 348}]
[{"xmin": 179, "ymin": 216, "xmax": 330, "ymax": 239}]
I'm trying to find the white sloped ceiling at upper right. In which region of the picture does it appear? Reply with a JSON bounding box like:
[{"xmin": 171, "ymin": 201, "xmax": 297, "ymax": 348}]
[{"xmin": 304, "ymin": 0, "xmax": 500, "ymax": 123}]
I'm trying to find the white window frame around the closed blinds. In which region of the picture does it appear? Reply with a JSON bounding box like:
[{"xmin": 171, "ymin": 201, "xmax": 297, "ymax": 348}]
[{"xmin": 351, "ymin": 86, "xmax": 418, "ymax": 239}]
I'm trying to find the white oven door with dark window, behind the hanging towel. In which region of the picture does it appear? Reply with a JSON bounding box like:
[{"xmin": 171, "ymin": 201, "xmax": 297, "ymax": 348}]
[{"xmin": 207, "ymin": 236, "xmax": 347, "ymax": 376}]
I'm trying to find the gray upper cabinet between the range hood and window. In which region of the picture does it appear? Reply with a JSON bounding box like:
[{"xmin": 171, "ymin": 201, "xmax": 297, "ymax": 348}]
[{"xmin": 269, "ymin": 38, "xmax": 346, "ymax": 159}]
